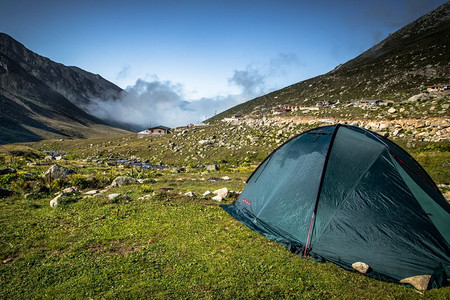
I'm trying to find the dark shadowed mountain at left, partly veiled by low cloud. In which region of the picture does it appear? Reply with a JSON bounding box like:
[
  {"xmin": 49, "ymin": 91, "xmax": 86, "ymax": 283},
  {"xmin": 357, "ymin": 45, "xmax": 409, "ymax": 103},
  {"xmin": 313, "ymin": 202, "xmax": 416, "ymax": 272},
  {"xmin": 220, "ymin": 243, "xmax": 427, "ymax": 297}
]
[{"xmin": 0, "ymin": 33, "xmax": 126, "ymax": 144}]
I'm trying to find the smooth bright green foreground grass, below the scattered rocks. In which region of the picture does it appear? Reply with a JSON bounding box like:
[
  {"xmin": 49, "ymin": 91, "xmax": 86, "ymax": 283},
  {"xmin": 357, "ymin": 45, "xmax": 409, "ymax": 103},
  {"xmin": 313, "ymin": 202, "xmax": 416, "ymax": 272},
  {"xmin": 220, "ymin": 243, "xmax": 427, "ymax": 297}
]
[{"xmin": 0, "ymin": 185, "xmax": 450, "ymax": 299}]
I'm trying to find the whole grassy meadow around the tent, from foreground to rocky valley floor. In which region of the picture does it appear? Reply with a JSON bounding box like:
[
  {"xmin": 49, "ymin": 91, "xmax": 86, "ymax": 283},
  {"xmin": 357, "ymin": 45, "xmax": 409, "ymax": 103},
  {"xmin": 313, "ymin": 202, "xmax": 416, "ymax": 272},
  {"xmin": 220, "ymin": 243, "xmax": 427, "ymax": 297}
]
[{"xmin": 0, "ymin": 125, "xmax": 450, "ymax": 299}]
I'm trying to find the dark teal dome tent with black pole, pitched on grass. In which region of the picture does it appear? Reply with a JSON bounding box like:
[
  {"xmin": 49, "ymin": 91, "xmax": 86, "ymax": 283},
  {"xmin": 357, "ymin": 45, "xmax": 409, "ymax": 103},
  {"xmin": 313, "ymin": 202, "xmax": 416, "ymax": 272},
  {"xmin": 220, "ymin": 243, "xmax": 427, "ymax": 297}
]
[{"xmin": 223, "ymin": 124, "xmax": 450, "ymax": 289}]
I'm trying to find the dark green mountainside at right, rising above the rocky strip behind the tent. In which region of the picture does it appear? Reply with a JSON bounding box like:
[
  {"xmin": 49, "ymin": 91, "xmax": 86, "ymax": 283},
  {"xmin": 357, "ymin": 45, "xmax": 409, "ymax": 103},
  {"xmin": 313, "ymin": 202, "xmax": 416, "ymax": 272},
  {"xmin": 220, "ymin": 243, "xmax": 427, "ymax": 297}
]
[{"xmin": 211, "ymin": 2, "xmax": 450, "ymax": 121}]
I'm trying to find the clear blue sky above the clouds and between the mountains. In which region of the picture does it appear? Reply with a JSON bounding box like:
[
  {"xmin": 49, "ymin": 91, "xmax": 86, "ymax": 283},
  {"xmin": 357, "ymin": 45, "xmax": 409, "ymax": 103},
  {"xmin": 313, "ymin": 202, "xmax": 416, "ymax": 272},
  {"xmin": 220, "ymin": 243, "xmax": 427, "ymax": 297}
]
[{"xmin": 0, "ymin": 0, "xmax": 446, "ymax": 126}]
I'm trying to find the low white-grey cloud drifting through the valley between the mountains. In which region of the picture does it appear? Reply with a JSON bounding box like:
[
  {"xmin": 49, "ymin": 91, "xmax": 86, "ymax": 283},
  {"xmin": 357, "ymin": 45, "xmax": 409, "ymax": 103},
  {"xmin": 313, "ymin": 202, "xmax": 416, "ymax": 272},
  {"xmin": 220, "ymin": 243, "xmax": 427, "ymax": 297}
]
[{"xmin": 86, "ymin": 54, "xmax": 298, "ymax": 128}]
